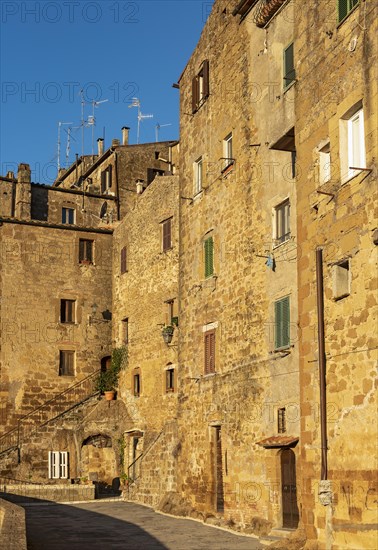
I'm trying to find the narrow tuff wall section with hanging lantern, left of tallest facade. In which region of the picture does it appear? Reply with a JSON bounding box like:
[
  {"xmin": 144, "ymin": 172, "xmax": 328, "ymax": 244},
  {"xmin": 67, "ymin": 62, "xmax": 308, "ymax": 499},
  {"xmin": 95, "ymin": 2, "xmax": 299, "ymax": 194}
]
[{"xmin": 113, "ymin": 176, "xmax": 180, "ymax": 504}]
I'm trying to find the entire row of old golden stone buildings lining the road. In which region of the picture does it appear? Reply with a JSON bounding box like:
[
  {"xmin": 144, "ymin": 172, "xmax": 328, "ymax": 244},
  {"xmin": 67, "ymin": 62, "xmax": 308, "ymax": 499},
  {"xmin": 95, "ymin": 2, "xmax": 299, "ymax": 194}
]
[{"xmin": 0, "ymin": 0, "xmax": 378, "ymax": 550}]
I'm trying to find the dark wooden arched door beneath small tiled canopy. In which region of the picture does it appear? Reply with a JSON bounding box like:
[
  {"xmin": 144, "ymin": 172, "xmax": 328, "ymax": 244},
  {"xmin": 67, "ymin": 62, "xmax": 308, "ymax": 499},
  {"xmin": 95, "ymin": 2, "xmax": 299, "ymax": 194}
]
[{"xmin": 281, "ymin": 449, "xmax": 299, "ymax": 528}]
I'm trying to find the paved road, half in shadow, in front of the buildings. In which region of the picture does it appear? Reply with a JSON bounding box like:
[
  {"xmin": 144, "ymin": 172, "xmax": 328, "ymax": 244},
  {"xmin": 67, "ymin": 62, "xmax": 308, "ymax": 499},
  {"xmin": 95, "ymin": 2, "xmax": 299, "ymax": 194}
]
[{"xmin": 25, "ymin": 501, "xmax": 262, "ymax": 550}]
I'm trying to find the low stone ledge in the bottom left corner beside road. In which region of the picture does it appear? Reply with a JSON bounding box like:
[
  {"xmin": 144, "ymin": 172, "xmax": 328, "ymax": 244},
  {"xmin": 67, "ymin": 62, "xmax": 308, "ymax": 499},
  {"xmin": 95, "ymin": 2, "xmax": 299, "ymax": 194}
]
[{"xmin": 0, "ymin": 499, "xmax": 27, "ymax": 550}]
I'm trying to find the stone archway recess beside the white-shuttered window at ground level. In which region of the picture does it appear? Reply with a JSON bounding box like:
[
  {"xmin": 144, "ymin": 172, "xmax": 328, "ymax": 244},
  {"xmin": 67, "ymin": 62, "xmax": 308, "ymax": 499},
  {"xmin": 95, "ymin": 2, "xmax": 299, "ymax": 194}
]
[{"xmin": 81, "ymin": 434, "xmax": 117, "ymax": 485}]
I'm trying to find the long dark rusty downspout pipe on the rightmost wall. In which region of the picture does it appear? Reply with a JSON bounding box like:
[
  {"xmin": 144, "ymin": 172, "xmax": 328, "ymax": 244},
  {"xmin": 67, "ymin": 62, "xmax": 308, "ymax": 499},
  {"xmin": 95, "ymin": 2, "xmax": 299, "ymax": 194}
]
[{"xmin": 316, "ymin": 248, "xmax": 328, "ymax": 481}]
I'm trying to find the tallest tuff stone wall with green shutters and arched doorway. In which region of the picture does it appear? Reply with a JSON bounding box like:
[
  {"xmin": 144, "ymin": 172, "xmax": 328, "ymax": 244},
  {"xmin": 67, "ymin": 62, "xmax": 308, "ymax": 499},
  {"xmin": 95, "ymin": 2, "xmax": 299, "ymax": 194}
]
[{"xmin": 179, "ymin": 1, "xmax": 299, "ymax": 531}]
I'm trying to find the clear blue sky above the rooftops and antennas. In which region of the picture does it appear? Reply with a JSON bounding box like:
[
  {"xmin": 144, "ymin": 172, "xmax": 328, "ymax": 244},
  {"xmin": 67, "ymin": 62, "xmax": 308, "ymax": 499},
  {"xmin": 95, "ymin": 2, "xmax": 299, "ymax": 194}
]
[{"xmin": 0, "ymin": 0, "xmax": 213, "ymax": 183}]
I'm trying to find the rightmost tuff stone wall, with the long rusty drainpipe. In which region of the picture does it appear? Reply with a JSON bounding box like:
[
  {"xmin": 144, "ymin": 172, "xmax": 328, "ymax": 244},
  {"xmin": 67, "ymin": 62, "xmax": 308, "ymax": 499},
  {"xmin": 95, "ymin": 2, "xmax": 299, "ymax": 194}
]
[{"xmin": 295, "ymin": 1, "xmax": 377, "ymax": 549}]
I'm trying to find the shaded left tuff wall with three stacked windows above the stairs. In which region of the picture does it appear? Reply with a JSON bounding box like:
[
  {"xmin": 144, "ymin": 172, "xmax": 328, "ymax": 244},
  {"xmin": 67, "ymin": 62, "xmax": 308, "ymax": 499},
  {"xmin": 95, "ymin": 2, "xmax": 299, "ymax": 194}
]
[{"xmin": 0, "ymin": 223, "xmax": 111, "ymax": 431}]
